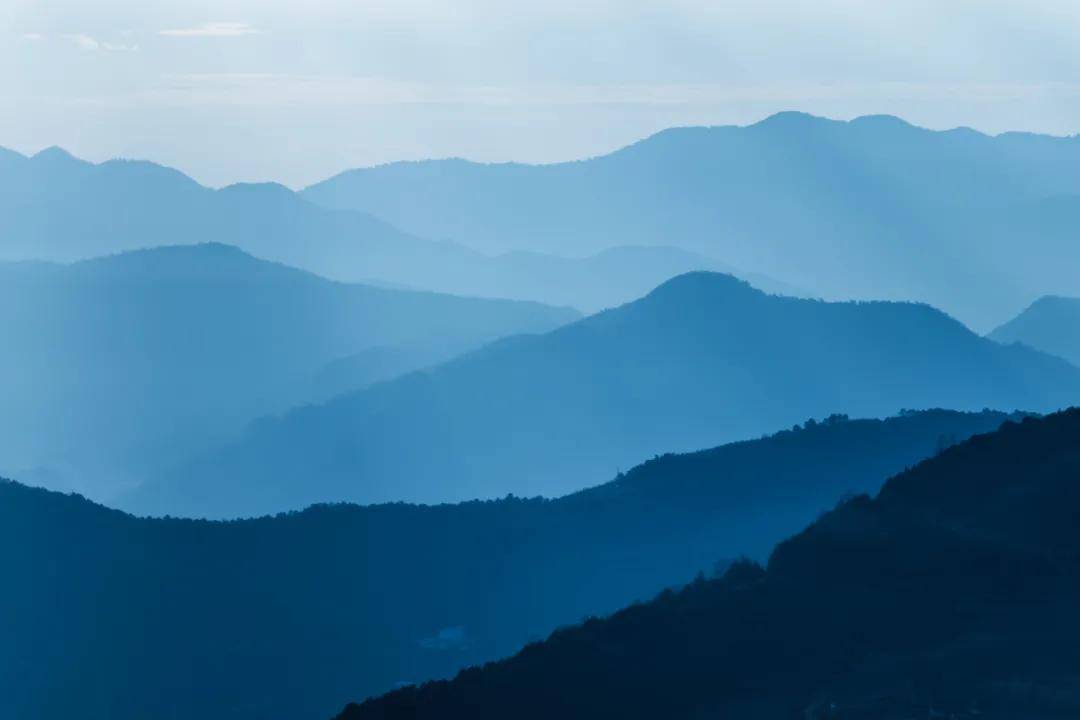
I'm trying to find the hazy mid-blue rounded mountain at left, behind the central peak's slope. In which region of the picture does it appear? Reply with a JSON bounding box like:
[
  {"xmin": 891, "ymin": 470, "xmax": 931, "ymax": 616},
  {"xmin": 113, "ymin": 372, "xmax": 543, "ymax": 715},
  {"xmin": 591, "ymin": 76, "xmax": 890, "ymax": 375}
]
[{"xmin": 0, "ymin": 245, "xmax": 577, "ymax": 505}]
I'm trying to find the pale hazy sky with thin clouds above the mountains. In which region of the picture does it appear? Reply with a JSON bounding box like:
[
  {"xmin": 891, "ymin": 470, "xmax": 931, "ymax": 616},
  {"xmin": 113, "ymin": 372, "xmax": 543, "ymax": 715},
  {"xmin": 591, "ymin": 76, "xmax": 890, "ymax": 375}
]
[{"xmin": 6, "ymin": 0, "xmax": 1080, "ymax": 188}]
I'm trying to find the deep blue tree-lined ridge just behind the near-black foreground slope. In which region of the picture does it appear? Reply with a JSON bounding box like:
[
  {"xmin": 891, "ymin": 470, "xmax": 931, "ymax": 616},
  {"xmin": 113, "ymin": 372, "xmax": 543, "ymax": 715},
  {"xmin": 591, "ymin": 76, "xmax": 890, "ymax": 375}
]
[{"xmin": 0, "ymin": 411, "xmax": 1005, "ymax": 720}]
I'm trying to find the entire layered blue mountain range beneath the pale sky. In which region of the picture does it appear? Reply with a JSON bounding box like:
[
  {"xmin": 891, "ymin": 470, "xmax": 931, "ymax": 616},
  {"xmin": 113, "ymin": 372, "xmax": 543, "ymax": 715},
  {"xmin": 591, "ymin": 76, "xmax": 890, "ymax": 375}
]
[{"xmin": 6, "ymin": 108, "xmax": 1080, "ymax": 720}]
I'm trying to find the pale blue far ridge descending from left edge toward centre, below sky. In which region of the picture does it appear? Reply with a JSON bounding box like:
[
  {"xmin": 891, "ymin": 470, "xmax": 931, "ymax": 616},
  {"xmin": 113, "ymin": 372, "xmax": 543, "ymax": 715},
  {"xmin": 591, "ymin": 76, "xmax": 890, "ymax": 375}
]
[{"xmin": 0, "ymin": 148, "xmax": 777, "ymax": 312}]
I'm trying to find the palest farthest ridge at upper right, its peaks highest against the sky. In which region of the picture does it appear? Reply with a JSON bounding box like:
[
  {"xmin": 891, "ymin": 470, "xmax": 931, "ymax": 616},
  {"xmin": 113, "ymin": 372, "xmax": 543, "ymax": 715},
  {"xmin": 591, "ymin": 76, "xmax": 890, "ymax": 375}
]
[{"xmin": 303, "ymin": 112, "xmax": 1080, "ymax": 330}]
